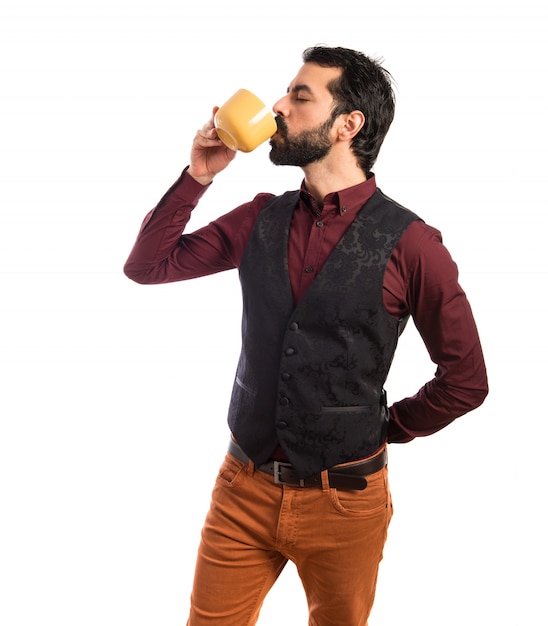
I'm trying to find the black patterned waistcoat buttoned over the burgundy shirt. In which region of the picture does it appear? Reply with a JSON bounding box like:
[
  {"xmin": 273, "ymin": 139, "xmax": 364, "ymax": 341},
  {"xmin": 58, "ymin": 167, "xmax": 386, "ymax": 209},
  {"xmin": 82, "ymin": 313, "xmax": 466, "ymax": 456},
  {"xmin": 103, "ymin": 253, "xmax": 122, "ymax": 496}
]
[{"xmin": 228, "ymin": 190, "xmax": 418, "ymax": 477}]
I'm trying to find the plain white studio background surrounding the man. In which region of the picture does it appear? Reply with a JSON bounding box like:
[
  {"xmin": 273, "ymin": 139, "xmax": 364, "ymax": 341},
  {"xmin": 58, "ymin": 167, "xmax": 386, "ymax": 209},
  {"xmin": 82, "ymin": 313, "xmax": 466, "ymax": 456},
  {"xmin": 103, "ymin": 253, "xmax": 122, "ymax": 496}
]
[{"xmin": 0, "ymin": 0, "xmax": 548, "ymax": 626}]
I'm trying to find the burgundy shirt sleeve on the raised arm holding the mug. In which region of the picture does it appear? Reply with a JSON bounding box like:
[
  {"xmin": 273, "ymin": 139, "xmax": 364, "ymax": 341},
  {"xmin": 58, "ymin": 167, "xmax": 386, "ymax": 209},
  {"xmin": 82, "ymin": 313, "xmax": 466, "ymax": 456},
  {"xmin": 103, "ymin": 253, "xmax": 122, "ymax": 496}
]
[{"xmin": 124, "ymin": 170, "xmax": 272, "ymax": 285}]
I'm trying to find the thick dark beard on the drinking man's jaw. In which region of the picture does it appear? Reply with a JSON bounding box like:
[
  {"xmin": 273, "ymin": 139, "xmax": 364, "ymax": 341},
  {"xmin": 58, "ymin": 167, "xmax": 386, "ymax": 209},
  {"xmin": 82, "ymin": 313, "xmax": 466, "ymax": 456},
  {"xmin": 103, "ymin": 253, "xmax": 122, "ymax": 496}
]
[{"xmin": 270, "ymin": 116, "xmax": 334, "ymax": 167}]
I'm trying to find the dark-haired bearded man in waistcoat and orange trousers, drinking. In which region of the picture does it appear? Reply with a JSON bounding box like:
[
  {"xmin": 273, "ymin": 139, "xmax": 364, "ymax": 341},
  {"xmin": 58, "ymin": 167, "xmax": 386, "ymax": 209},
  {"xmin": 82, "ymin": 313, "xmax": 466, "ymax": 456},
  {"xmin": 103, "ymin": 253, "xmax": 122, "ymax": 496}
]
[{"xmin": 125, "ymin": 47, "xmax": 487, "ymax": 626}]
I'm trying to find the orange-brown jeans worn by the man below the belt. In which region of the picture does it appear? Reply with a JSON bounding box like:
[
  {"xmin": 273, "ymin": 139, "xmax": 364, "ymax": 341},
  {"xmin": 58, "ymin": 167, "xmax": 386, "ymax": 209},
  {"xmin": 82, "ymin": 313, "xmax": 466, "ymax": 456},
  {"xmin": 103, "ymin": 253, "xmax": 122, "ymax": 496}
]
[{"xmin": 187, "ymin": 446, "xmax": 392, "ymax": 626}]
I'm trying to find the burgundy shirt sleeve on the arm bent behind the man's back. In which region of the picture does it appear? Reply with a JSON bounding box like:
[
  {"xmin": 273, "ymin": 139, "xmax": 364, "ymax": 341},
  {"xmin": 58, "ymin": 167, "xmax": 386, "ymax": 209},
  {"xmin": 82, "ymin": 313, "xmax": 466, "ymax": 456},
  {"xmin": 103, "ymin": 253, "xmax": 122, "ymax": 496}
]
[{"xmin": 387, "ymin": 221, "xmax": 488, "ymax": 443}]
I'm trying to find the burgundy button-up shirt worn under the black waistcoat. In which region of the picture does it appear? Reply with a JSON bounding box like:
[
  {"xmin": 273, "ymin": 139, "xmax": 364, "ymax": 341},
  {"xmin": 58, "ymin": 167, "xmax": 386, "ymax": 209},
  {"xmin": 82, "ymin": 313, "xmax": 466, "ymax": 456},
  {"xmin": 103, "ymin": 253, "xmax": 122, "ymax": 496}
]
[{"xmin": 124, "ymin": 172, "xmax": 488, "ymax": 443}]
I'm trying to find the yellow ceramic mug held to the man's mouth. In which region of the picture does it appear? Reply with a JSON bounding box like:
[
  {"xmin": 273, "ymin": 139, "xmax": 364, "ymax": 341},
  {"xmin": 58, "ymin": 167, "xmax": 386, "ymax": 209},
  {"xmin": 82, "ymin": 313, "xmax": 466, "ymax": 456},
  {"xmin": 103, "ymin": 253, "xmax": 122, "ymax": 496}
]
[{"xmin": 214, "ymin": 89, "xmax": 277, "ymax": 152}]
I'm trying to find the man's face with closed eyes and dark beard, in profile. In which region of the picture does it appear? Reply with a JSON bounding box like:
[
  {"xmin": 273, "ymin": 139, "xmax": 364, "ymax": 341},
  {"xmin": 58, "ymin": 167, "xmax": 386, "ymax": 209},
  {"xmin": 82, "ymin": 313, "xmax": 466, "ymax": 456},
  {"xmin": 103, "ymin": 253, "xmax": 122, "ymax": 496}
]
[{"xmin": 270, "ymin": 63, "xmax": 341, "ymax": 167}]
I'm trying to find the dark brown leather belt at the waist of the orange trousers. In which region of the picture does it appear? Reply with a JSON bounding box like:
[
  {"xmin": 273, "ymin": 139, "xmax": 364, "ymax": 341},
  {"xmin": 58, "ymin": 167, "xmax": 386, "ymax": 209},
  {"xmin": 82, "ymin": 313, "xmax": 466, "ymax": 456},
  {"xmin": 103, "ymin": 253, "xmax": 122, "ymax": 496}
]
[{"xmin": 228, "ymin": 439, "xmax": 388, "ymax": 490}]
